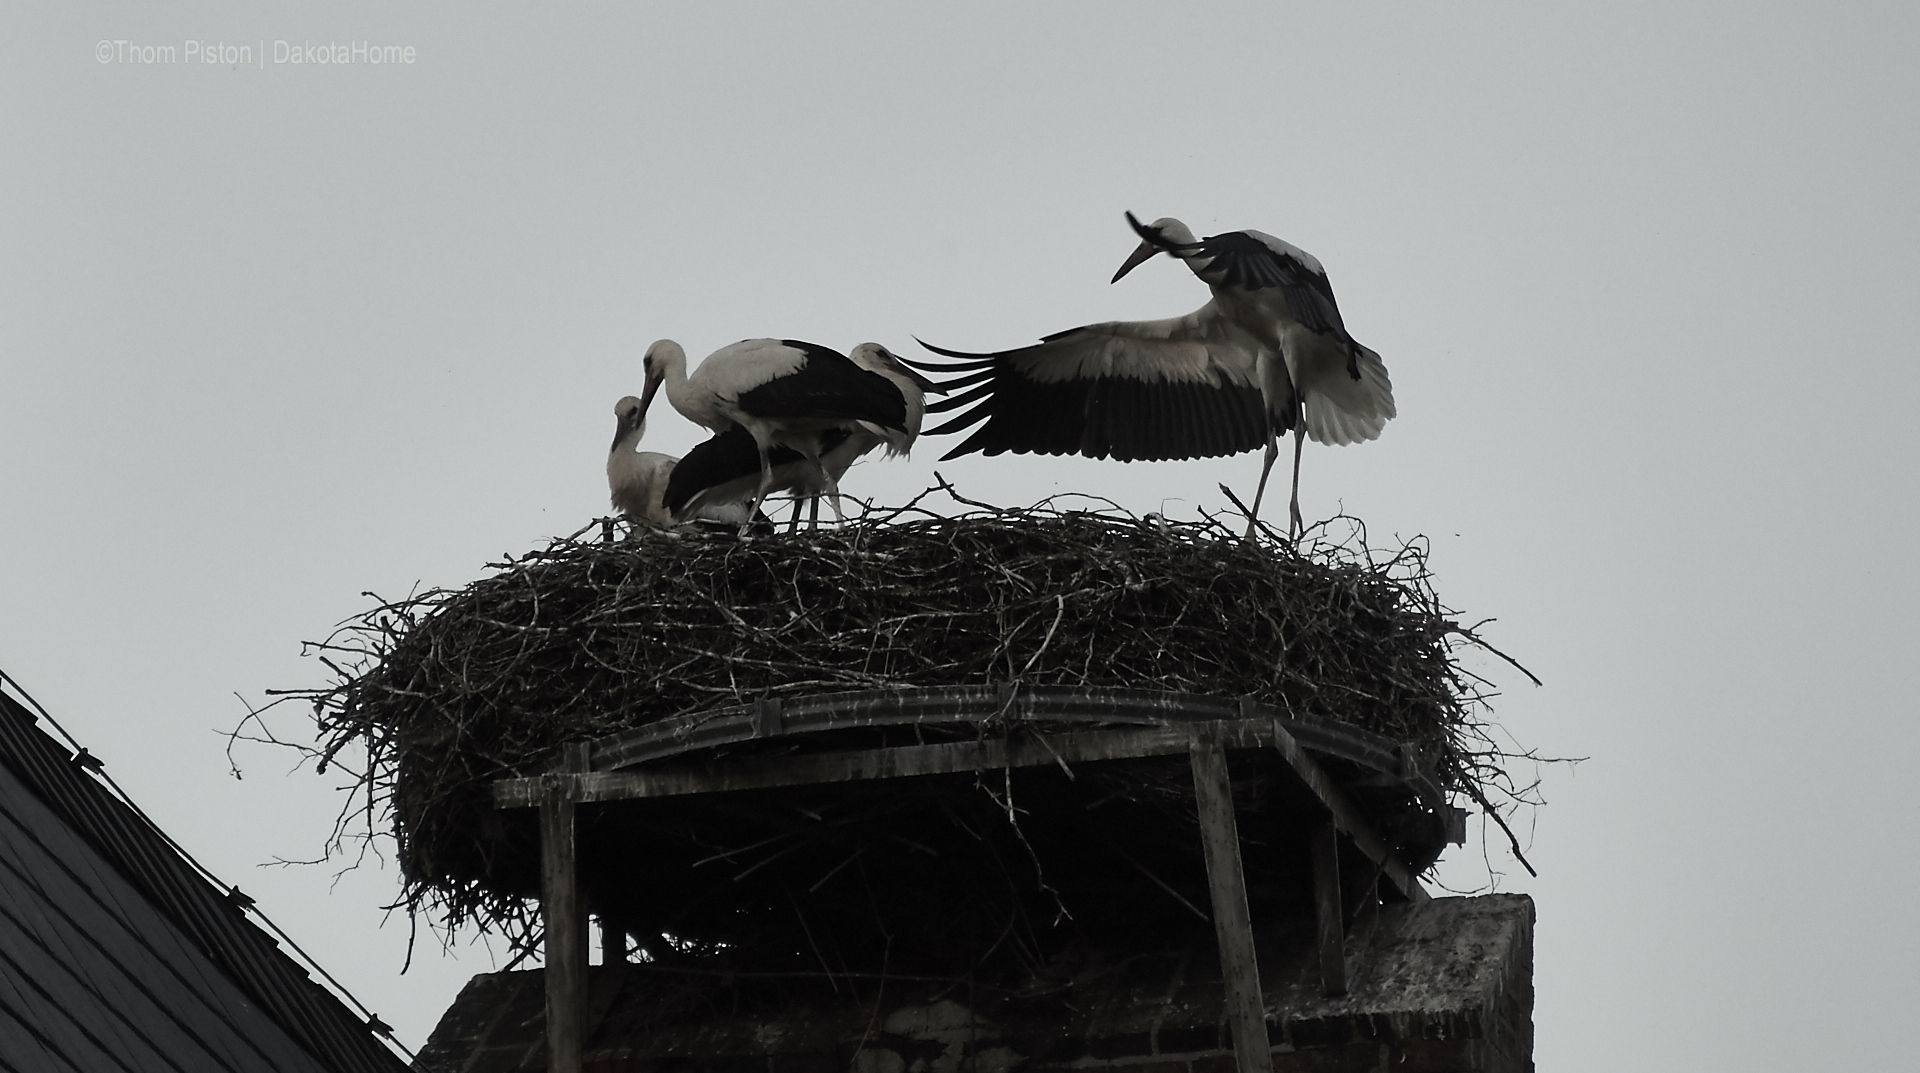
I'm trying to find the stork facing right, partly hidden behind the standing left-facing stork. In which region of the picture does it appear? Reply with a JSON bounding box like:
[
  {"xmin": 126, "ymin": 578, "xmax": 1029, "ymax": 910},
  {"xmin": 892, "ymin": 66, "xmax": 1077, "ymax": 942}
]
[{"xmin": 664, "ymin": 344, "xmax": 937, "ymax": 532}]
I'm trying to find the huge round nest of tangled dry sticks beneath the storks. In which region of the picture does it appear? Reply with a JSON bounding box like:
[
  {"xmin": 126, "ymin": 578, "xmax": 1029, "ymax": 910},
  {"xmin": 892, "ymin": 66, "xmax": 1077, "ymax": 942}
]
[{"xmin": 270, "ymin": 491, "xmax": 1511, "ymax": 971}]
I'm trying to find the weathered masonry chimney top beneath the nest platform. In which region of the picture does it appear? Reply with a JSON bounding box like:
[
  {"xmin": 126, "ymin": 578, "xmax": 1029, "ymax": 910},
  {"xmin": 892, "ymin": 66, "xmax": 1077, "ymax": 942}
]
[{"xmin": 420, "ymin": 894, "xmax": 1534, "ymax": 1073}]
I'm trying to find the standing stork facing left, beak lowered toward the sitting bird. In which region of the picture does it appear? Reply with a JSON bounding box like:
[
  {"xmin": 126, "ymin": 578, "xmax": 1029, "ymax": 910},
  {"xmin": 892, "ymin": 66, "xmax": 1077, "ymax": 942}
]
[{"xmin": 639, "ymin": 340, "xmax": 910, "ymax": 532}]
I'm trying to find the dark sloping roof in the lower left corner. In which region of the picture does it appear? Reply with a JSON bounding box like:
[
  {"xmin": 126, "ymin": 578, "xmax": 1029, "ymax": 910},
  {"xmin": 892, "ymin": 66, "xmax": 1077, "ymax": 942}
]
[{"xmin": 0, "ymin": 679, "xmax": 407, "ymax": 1073}]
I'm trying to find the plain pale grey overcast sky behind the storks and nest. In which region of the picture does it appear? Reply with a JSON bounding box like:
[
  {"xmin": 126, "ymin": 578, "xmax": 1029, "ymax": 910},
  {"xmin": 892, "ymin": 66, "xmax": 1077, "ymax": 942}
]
[{"xmin": 0, "ymin": 0, "xmax": 1920, "ymax": 1071}]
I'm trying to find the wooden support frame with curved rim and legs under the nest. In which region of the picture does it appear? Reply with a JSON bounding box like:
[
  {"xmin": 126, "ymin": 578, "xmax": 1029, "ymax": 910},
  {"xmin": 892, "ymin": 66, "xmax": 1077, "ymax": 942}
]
[{"xmin": 493, "ymin": 687, "xmax": 1465, "ymax": 1073}]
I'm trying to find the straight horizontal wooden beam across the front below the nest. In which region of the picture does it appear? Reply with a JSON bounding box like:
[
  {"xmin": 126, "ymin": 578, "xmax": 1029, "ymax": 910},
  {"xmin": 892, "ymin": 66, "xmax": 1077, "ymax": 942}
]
[{"xmin": 493, "ymin": 720, "xmax": 1273, "ymax": 808}]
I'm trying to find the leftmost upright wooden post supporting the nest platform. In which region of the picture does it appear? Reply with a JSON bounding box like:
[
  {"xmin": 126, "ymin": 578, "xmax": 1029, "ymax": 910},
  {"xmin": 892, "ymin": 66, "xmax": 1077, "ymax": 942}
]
[{"xmin": 540, "ymin": 775, "xmax": 588, "ymax": 1073}]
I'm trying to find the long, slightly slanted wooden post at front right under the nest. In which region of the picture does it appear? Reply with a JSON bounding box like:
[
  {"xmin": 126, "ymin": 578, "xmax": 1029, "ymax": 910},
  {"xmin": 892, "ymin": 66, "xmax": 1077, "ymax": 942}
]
[{"xmin": 1187, "ymin": 733, "xmax": 1273, "ymax": 1073}]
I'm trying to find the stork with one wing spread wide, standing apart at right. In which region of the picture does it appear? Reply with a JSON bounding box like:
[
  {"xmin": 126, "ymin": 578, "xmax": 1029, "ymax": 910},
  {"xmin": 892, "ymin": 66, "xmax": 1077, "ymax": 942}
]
[{"xmin": 920, "ymin": 213, "xmax": 1394, "ymax": 534}]
